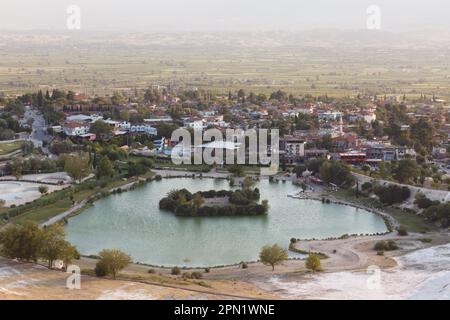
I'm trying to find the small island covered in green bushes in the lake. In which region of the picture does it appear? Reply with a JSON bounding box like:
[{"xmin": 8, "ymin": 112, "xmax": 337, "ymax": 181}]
[{"xmin": 159, "ymin": 188, "xmax": 269, "ymax": 217}]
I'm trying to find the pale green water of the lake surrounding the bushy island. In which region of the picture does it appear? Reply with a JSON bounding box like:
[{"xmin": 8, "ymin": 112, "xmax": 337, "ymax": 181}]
[{"xmin": 67, "ymin": 178, "xmax": 386, "ymax": 266}]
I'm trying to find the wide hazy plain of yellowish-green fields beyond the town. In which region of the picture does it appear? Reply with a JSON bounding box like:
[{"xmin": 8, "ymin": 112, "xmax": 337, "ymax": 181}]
[{"xmin": 0, "ymin": 34, "xmax": 450, "ymax": 98}]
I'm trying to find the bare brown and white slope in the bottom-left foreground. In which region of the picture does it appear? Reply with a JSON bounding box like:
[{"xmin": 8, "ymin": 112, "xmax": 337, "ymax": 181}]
[{"xmin": 0, "ymin": 258, "xmax": 277, "ymax": 300}]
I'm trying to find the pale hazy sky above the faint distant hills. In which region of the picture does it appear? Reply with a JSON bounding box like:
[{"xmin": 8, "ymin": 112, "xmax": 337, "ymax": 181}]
[{"xmin": 0, "ymin": 0, "xmax": 450, "ymax": 32}]
